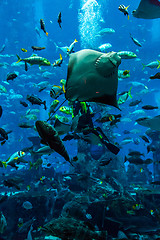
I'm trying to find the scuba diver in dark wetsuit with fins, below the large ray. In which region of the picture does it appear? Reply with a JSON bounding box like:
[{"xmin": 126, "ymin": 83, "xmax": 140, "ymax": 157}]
[{"xmin": 63, "ymin": 101, "xmax": 120, "ymax": 155}]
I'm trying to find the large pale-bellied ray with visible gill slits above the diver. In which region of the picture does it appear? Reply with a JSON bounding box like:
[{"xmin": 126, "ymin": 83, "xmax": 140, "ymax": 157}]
[{"xmin": 65, "ymin": 49, "xmax": 121, "ymax": 108}]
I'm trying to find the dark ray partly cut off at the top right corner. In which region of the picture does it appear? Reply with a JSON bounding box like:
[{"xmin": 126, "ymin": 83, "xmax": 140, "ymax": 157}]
[{"xmin": 132, "ymin": 0, "xmax": 160, "ymax": 19}]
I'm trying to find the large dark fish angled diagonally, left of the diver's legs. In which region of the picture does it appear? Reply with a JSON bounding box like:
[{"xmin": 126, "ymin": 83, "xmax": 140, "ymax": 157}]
[{"xmin": 36, "ymin": 121, "xmax": 72, "ymax": 165}]
